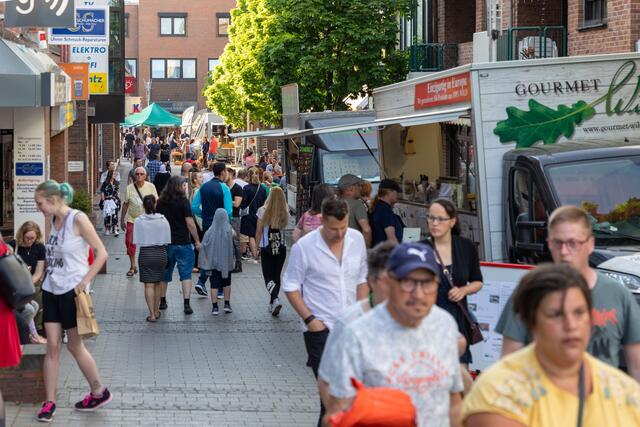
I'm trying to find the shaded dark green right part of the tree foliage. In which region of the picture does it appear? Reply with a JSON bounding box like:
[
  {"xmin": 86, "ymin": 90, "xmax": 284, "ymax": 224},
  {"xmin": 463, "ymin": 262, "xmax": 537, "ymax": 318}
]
[{"xmin": 259, "ymin": 0, "xmax": 410, "ymax": 111}]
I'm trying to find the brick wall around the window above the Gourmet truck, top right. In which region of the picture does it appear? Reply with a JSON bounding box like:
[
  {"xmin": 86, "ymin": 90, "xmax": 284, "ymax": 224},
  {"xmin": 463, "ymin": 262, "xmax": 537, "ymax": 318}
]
[{"xmin": 567, "ymin": 0, "xmax": 640, "ymax": 56}]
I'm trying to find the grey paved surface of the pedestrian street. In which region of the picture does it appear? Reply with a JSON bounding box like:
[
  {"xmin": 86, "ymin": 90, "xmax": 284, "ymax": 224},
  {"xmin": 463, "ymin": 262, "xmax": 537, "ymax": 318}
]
[{"xmin": 7, "ymin": 161, "xmax": 319, "ymax": 426}]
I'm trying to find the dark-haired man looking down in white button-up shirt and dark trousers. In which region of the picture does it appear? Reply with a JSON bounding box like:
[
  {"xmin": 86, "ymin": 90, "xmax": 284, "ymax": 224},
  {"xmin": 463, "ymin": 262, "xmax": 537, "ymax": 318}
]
[{"xmin": 282, "ymin": 198, "xmax": 369, "ymax": 423}]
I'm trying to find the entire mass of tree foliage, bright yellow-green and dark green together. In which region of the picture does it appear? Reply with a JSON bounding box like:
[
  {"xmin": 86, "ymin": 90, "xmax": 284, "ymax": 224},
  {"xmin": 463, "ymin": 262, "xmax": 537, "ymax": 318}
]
[{"xmin": 205, "ymin": 0, "xmax": 410, "ymax": 127}]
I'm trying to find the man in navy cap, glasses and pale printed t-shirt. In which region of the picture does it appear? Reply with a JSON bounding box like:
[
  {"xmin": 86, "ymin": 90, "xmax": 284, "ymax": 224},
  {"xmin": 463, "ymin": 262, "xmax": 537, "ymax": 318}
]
[{"xmin": 325, "ymin": 243, "xmax": 463, "ymax": 426}]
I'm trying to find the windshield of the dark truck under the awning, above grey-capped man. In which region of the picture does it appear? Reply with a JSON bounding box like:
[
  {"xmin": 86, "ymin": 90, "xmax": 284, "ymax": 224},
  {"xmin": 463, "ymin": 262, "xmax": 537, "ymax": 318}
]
[{"xmin": 322, "ymin": 150, "xmax": 380, "ymax": 185}]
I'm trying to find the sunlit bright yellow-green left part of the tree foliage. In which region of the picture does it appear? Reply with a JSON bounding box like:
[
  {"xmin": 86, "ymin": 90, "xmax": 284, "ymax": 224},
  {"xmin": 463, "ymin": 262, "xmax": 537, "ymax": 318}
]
[{"xmin": 203, "ymin": 0, "xmax": 278, "ymax": 128}]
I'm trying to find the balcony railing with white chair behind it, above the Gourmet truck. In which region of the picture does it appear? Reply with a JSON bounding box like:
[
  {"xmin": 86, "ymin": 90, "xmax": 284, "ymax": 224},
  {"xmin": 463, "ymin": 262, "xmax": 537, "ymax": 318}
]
[{"xmin": 498, "ymin": 25, "xmax": 567, "ymax": 61}]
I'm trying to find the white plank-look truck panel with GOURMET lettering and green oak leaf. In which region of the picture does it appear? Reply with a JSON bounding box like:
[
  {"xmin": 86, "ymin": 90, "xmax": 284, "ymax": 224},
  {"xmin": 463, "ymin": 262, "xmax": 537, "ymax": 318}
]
[{"xmin": 488, "ymin": 59, "xmax": 640, "ymax": 148}]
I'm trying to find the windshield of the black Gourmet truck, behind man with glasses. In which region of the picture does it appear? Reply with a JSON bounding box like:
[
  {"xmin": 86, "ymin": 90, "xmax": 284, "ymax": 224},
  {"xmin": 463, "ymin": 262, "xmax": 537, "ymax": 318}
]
[{"xmin": 547, "ymin": 156, "xmax": 640, "ymax": 245}]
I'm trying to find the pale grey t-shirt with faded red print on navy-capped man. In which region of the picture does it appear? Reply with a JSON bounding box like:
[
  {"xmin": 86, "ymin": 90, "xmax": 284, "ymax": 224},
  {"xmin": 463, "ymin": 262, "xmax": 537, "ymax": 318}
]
[{"xmin": 322, "ymin": 304, "xmax": 463, "ymax": 426}]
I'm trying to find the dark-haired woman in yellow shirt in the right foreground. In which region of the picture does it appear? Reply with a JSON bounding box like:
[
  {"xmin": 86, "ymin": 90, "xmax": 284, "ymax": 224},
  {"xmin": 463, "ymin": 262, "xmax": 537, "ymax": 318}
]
[{"xmin": 462, "ymin": 265, "xmax": 640, "ymax": 427}]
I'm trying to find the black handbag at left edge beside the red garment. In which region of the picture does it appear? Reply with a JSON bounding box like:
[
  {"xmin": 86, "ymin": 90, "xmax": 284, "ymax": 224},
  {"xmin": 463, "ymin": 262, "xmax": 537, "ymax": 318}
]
[{"xmin": 0, "ymin": 253, "xmax": 36, "ymax": 309}]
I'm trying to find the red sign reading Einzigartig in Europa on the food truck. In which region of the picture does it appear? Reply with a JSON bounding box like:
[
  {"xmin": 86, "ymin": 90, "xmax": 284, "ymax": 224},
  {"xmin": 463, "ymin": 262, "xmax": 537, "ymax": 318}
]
[{"xmin": 413, "ymin": 72, "xmax": 471, "ymax": 110}]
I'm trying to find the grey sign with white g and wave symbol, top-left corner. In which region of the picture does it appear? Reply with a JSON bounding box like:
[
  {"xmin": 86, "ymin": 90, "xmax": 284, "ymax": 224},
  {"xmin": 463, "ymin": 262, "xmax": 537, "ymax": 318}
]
[{"xmin": 4, "ymin": 0, "xmax": 76, "ymax": 28}]
